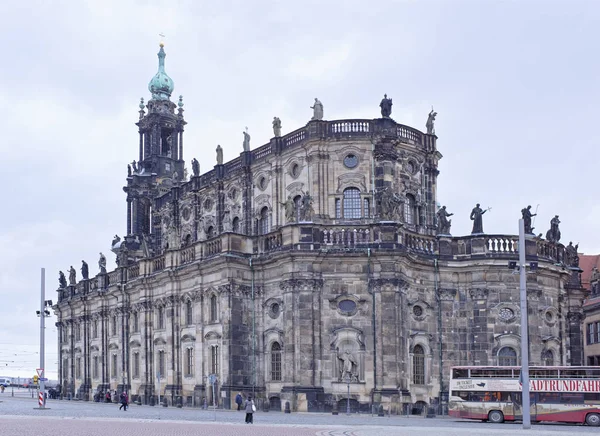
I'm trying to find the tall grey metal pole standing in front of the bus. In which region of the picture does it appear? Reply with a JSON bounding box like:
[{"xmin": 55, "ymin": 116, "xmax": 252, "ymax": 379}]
[{"xmin": 519, "ymin": 219, "xmax": 531, "ymax": 429}]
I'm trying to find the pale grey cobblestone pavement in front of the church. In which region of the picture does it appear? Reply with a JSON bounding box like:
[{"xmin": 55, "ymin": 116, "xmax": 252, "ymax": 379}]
[{"xmin": 0, "ymin": 391, "xmax": 598, "ymax": 436}]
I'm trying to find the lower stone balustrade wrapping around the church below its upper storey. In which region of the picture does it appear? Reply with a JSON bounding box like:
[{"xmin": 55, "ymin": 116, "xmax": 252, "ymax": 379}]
[{"xmin": 58, "ymin": 222, "xmax": 564, "ymax": 301}]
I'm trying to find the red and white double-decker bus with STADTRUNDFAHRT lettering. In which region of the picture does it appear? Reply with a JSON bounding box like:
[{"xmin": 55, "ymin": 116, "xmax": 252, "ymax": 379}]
[{"xmin": 448, "ymin": 366, "xmax": 600, "ymax": 426}]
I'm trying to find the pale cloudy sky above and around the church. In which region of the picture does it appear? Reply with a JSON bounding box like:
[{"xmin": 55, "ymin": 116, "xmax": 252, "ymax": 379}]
[{"xmin": 0, "ymin": 0, "xmax": 600, "ymax": 378}]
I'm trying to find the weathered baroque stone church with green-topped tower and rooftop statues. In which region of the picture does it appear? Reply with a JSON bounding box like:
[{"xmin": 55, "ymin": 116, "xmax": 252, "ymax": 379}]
[{"xmin": 54, "ymin": 45, "xmax": 584, "ymax": 413}]
